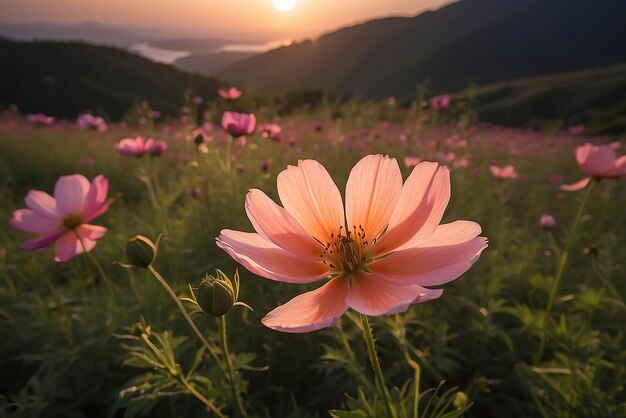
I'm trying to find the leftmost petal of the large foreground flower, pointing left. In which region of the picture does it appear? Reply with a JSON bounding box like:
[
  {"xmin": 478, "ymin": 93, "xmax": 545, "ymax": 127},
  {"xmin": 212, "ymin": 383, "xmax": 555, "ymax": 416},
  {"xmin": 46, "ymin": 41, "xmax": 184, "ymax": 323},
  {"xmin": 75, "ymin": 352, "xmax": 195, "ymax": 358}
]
[{"xmin": 217, "ymin": 229, "xmax": 330, "ymax": 283}]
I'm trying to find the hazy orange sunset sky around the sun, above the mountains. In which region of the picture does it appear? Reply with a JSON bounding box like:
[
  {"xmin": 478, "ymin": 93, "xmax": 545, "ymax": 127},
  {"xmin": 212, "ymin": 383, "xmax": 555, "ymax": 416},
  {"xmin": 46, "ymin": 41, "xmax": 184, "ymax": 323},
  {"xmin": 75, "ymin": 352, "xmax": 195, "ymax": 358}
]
[{"xmin": 0, "ymin": 0, "xmax": 452, "ymax": 39}]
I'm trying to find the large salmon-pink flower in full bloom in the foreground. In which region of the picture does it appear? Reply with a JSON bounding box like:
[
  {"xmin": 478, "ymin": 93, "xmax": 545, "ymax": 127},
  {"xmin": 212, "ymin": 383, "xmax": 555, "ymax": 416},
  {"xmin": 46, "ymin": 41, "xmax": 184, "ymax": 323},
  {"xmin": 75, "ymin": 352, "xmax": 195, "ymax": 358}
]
[{"xmin": 217, "ymin": 155, "xmax": 487, "ymax": 332}]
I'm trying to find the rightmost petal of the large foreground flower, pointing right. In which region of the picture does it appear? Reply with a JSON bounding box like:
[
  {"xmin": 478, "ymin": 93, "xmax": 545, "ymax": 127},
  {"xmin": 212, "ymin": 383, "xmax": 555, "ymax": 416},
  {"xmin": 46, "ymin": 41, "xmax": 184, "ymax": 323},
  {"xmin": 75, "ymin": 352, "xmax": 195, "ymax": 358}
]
[{"xmin": 368, "ymin": 221, "xmax": 487, "ymax": 286}]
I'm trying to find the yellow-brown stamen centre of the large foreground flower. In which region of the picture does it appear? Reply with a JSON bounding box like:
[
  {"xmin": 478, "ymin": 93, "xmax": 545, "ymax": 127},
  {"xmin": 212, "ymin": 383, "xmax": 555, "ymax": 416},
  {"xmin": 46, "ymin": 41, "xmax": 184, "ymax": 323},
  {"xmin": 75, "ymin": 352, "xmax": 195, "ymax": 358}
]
[{"xmin": 321, "ymin": 225, "xmax": 376, "ymax": 275}]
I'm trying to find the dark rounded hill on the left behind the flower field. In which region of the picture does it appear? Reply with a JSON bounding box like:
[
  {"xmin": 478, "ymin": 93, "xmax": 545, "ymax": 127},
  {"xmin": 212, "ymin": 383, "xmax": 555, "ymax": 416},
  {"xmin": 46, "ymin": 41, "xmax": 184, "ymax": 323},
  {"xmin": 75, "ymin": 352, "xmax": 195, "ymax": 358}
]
[{"xmin": 0, "ymin": 39, "xmax": 218, "ymax": 120}]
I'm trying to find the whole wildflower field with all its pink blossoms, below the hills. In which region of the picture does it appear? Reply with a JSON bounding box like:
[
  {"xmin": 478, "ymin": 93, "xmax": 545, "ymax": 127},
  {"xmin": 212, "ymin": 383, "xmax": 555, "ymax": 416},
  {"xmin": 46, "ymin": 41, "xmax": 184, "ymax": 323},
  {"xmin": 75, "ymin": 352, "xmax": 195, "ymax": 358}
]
[{"xmin": 0, "ymin": 99, "xmax": 626, "ymax": 418}]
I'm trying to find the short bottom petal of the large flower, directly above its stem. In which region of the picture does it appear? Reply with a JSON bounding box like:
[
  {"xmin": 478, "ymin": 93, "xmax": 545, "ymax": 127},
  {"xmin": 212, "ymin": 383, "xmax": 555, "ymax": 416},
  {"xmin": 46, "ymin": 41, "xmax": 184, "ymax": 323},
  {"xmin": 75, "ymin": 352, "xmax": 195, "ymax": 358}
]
[{"xmin": 346, "ymin": 273, "xmax": 443, "ymax": 316}]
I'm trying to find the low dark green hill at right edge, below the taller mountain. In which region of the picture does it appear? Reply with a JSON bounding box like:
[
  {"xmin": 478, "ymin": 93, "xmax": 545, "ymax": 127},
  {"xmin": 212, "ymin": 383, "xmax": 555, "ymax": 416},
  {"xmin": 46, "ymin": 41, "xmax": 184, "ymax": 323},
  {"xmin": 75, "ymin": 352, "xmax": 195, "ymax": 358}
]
[{"xmin": 476, "ymin": 63, "xmax": 626, "ymax": 134}]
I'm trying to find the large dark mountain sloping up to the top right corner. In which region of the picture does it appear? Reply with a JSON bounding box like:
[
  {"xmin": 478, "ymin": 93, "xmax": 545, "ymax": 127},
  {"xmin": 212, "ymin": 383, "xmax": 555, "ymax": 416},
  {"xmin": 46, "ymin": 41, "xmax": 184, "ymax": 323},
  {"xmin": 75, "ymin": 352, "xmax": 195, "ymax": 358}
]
[{"xmin": 215, "ymin": 0, "xmax": 626, "ymax": 98}]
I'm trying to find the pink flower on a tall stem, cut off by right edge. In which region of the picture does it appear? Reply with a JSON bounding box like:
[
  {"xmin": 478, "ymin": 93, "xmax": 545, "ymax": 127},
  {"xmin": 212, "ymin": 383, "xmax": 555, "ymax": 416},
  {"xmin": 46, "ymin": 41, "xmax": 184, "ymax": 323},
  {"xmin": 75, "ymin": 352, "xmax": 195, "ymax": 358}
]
[{"xmin": 561, "ymin": 143, "xmax": 626, "ymax": 192}]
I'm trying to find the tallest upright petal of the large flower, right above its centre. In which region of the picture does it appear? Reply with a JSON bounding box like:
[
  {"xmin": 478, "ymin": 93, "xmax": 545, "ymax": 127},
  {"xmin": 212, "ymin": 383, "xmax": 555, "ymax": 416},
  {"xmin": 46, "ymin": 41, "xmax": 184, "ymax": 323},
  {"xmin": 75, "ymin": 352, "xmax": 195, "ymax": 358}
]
[{"xmin": 346, "ymin": 154, "xmax": 402, "ymax": 240}]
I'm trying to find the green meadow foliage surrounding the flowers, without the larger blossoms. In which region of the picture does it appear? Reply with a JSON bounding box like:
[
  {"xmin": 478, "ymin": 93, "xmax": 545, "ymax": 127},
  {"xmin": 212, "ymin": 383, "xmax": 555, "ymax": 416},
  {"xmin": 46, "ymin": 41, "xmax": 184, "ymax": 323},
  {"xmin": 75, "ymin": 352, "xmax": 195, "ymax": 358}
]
[{"xmin": 0, "ymin": 95, "xmax": 626, "ymax": 418}]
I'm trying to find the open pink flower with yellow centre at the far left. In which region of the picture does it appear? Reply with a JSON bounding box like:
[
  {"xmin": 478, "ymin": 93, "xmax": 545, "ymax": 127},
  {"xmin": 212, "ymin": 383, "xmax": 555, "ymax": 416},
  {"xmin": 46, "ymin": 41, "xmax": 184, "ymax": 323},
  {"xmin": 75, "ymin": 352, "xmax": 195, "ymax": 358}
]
[{"xmin": 11, "ymin": 174, "xmax": 111, "ymax": 262}]
